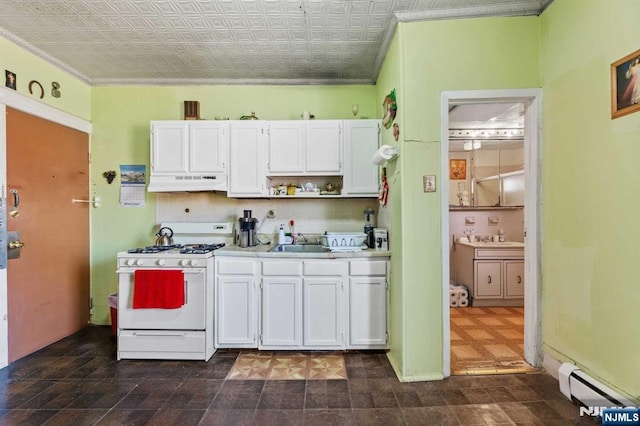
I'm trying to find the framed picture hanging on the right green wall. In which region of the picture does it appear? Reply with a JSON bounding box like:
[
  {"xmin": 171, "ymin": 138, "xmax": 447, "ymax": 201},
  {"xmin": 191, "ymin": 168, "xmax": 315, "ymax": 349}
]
[{"xmin": 611, "ymin": 50, "xmax": 640, "ymax": 118}]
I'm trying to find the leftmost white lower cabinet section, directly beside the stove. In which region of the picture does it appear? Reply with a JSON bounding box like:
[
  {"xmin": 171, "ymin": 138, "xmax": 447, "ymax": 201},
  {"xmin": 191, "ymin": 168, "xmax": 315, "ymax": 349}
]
[{"xmin": 215, "ymin": 257, "xmax": 259, "ymax": 348}]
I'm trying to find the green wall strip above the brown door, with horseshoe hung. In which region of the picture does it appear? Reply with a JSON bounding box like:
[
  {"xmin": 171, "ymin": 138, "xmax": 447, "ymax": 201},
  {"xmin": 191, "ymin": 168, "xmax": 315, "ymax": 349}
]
[{"xmin": 0, "ymin": 37, "xmax": 91, "ymax": 120}]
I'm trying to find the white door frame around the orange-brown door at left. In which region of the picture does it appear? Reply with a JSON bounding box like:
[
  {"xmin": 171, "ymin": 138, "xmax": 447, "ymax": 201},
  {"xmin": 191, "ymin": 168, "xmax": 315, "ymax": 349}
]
[{"xmin": 0, "ymin": 87, "xmax": 92, "ymax": 368}]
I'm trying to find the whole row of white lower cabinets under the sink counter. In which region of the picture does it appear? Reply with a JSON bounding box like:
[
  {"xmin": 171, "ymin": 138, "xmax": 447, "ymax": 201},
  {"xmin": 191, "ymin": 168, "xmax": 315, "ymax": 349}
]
[{"xmin": 216, "ymin": 256, "xmax": 388, "ymax": 350}]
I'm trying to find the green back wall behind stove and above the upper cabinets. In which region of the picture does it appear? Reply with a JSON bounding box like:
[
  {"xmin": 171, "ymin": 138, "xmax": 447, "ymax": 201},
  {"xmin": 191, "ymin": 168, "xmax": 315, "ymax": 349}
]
[{"xmin": 91, "ymin": 85, "xmax": 377, "ymax": 324}]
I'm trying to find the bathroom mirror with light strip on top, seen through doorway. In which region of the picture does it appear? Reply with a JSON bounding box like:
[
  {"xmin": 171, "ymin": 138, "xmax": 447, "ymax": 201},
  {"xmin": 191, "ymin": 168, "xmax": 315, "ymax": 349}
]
[{"xmin": 449, "ymin": 103, "xmax": 524, "ymax": 208}]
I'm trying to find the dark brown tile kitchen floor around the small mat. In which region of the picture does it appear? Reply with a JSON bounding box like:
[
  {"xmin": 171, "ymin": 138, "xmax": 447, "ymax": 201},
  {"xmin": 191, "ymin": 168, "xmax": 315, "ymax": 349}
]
[{"xmin": 0, "ymin": 327, "xmax": 593, "ymax": 426}]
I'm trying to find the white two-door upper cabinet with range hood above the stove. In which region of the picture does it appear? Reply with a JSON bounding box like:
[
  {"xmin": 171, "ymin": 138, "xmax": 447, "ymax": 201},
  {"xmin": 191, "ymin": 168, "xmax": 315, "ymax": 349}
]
[{"xmin": 148, "ymin": 121, "xmax": 229, "ymax": 192}]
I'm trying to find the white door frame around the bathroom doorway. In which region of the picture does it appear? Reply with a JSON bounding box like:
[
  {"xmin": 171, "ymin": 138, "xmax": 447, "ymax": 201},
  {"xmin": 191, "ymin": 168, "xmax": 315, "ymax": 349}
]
[{"xmin": 440, "ymin": 89, "xmax": 542, "ymax": 377}]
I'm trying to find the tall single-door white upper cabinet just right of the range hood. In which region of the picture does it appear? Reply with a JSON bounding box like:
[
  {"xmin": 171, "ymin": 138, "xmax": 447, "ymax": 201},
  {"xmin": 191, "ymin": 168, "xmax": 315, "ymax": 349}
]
[{"xmin": 227, "ymin": 120, "xmax": 267, "ymax": 198}]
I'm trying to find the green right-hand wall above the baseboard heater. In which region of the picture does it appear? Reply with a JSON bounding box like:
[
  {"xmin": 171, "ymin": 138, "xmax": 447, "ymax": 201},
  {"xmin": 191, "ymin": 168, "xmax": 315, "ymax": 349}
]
[{"xmin": 541, "ymin": 0, "xmax": 640, "ymax": 396}]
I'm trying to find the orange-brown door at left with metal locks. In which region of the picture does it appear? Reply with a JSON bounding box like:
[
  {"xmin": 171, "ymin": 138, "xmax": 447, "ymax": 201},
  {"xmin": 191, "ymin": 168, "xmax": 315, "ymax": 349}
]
[{"xmin": 7, "ymin": 108, "xmax": 91, "ymax": 362}]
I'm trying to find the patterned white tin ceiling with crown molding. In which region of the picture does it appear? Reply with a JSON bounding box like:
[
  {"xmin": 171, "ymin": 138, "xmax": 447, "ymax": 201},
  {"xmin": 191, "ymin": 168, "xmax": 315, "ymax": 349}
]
[{"xmin": 0, "ymin": 0, "xmax": 552, "ymax": 85}]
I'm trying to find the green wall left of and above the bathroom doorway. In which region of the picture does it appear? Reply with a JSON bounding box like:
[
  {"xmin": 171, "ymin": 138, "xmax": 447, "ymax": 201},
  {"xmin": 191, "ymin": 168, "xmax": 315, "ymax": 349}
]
[{"xmin": 378, "ymin": 17, "xmax": 540, "ymax": 380}]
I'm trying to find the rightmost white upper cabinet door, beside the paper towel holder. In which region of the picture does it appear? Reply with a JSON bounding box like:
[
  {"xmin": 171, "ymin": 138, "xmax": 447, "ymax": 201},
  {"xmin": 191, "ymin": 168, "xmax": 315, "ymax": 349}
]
[{"xmin": 342, "ymin": 120, "xmax": 380, "ymax": 197}]
